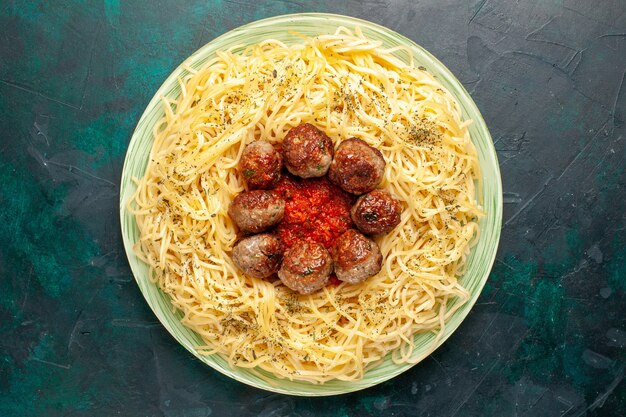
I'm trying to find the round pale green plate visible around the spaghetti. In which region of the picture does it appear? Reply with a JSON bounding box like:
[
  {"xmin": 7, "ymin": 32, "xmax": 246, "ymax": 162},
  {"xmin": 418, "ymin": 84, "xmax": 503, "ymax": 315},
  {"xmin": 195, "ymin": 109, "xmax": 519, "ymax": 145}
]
[{"xmin": 120, "ymin": 13, "xmax": 502, "ymax": 396}]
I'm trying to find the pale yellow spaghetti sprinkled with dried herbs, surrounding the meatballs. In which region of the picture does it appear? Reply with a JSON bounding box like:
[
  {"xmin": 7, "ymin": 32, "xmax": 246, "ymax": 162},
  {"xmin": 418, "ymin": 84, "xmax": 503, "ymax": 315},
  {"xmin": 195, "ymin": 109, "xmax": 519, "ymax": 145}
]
[{"xmin": 129, "ymin": 28, "xmax": 481, "ymax": 383}]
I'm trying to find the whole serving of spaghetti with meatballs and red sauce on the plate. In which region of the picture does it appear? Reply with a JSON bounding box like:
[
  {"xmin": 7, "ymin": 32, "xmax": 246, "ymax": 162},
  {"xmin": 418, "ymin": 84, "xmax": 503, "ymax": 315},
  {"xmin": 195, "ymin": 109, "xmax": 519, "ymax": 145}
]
[{"xmin": 130, "ymin": 28, "xmax": 482, "ymax": 383}]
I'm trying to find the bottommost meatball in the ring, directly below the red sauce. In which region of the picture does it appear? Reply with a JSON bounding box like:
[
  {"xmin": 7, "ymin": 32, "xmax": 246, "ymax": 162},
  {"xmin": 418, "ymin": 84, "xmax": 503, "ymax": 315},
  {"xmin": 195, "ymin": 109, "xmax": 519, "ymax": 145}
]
[{"xmin": 278, "ymin": 240, "xmax": 333, "ymax": 294}]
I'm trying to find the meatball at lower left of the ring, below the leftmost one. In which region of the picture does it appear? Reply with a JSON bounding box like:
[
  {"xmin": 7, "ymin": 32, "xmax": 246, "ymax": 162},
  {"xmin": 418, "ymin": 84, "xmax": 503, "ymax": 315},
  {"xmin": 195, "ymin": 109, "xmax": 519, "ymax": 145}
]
[{"xmin": 233, "ymin": 233, "xmax": 282, "ymax": 278}]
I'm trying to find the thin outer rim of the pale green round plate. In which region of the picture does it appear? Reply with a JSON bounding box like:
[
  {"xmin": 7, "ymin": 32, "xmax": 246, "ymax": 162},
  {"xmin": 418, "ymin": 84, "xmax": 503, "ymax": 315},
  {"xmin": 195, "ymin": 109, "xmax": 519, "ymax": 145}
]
[{"xmin": 119, "ymin": 12, "xmax": 503, "ymax": 397}]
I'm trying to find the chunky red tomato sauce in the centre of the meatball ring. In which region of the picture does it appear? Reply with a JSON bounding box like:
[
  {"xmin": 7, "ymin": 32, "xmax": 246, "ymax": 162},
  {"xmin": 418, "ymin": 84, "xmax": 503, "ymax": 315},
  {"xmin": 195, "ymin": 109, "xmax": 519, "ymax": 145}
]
[{"xmin": 275, "ymin": 175, "xmax": 355, "ymax": 249}]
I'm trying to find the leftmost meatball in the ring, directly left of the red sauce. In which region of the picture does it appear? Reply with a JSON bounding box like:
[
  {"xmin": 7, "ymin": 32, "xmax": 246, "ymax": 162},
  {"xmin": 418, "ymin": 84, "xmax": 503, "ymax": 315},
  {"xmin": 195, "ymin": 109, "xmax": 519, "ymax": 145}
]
[{"xmin": 228, "ymin": 190, "xmax": 285, "ymax": 233}]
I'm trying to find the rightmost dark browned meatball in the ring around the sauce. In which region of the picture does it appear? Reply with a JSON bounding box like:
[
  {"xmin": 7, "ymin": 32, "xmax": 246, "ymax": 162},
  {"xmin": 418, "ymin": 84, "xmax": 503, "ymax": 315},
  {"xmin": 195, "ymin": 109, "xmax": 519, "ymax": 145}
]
[{"xmin": 350, "ymin": 190, "xmax": 402, "ymax": 234}]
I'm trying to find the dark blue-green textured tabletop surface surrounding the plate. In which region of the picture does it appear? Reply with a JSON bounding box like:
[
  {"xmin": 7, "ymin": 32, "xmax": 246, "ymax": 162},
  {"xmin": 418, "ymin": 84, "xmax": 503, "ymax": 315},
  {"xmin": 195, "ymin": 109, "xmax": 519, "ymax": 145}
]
[{"xmin": 0, "ymin": 0, "xmax": 626, "ymax": 417}]
